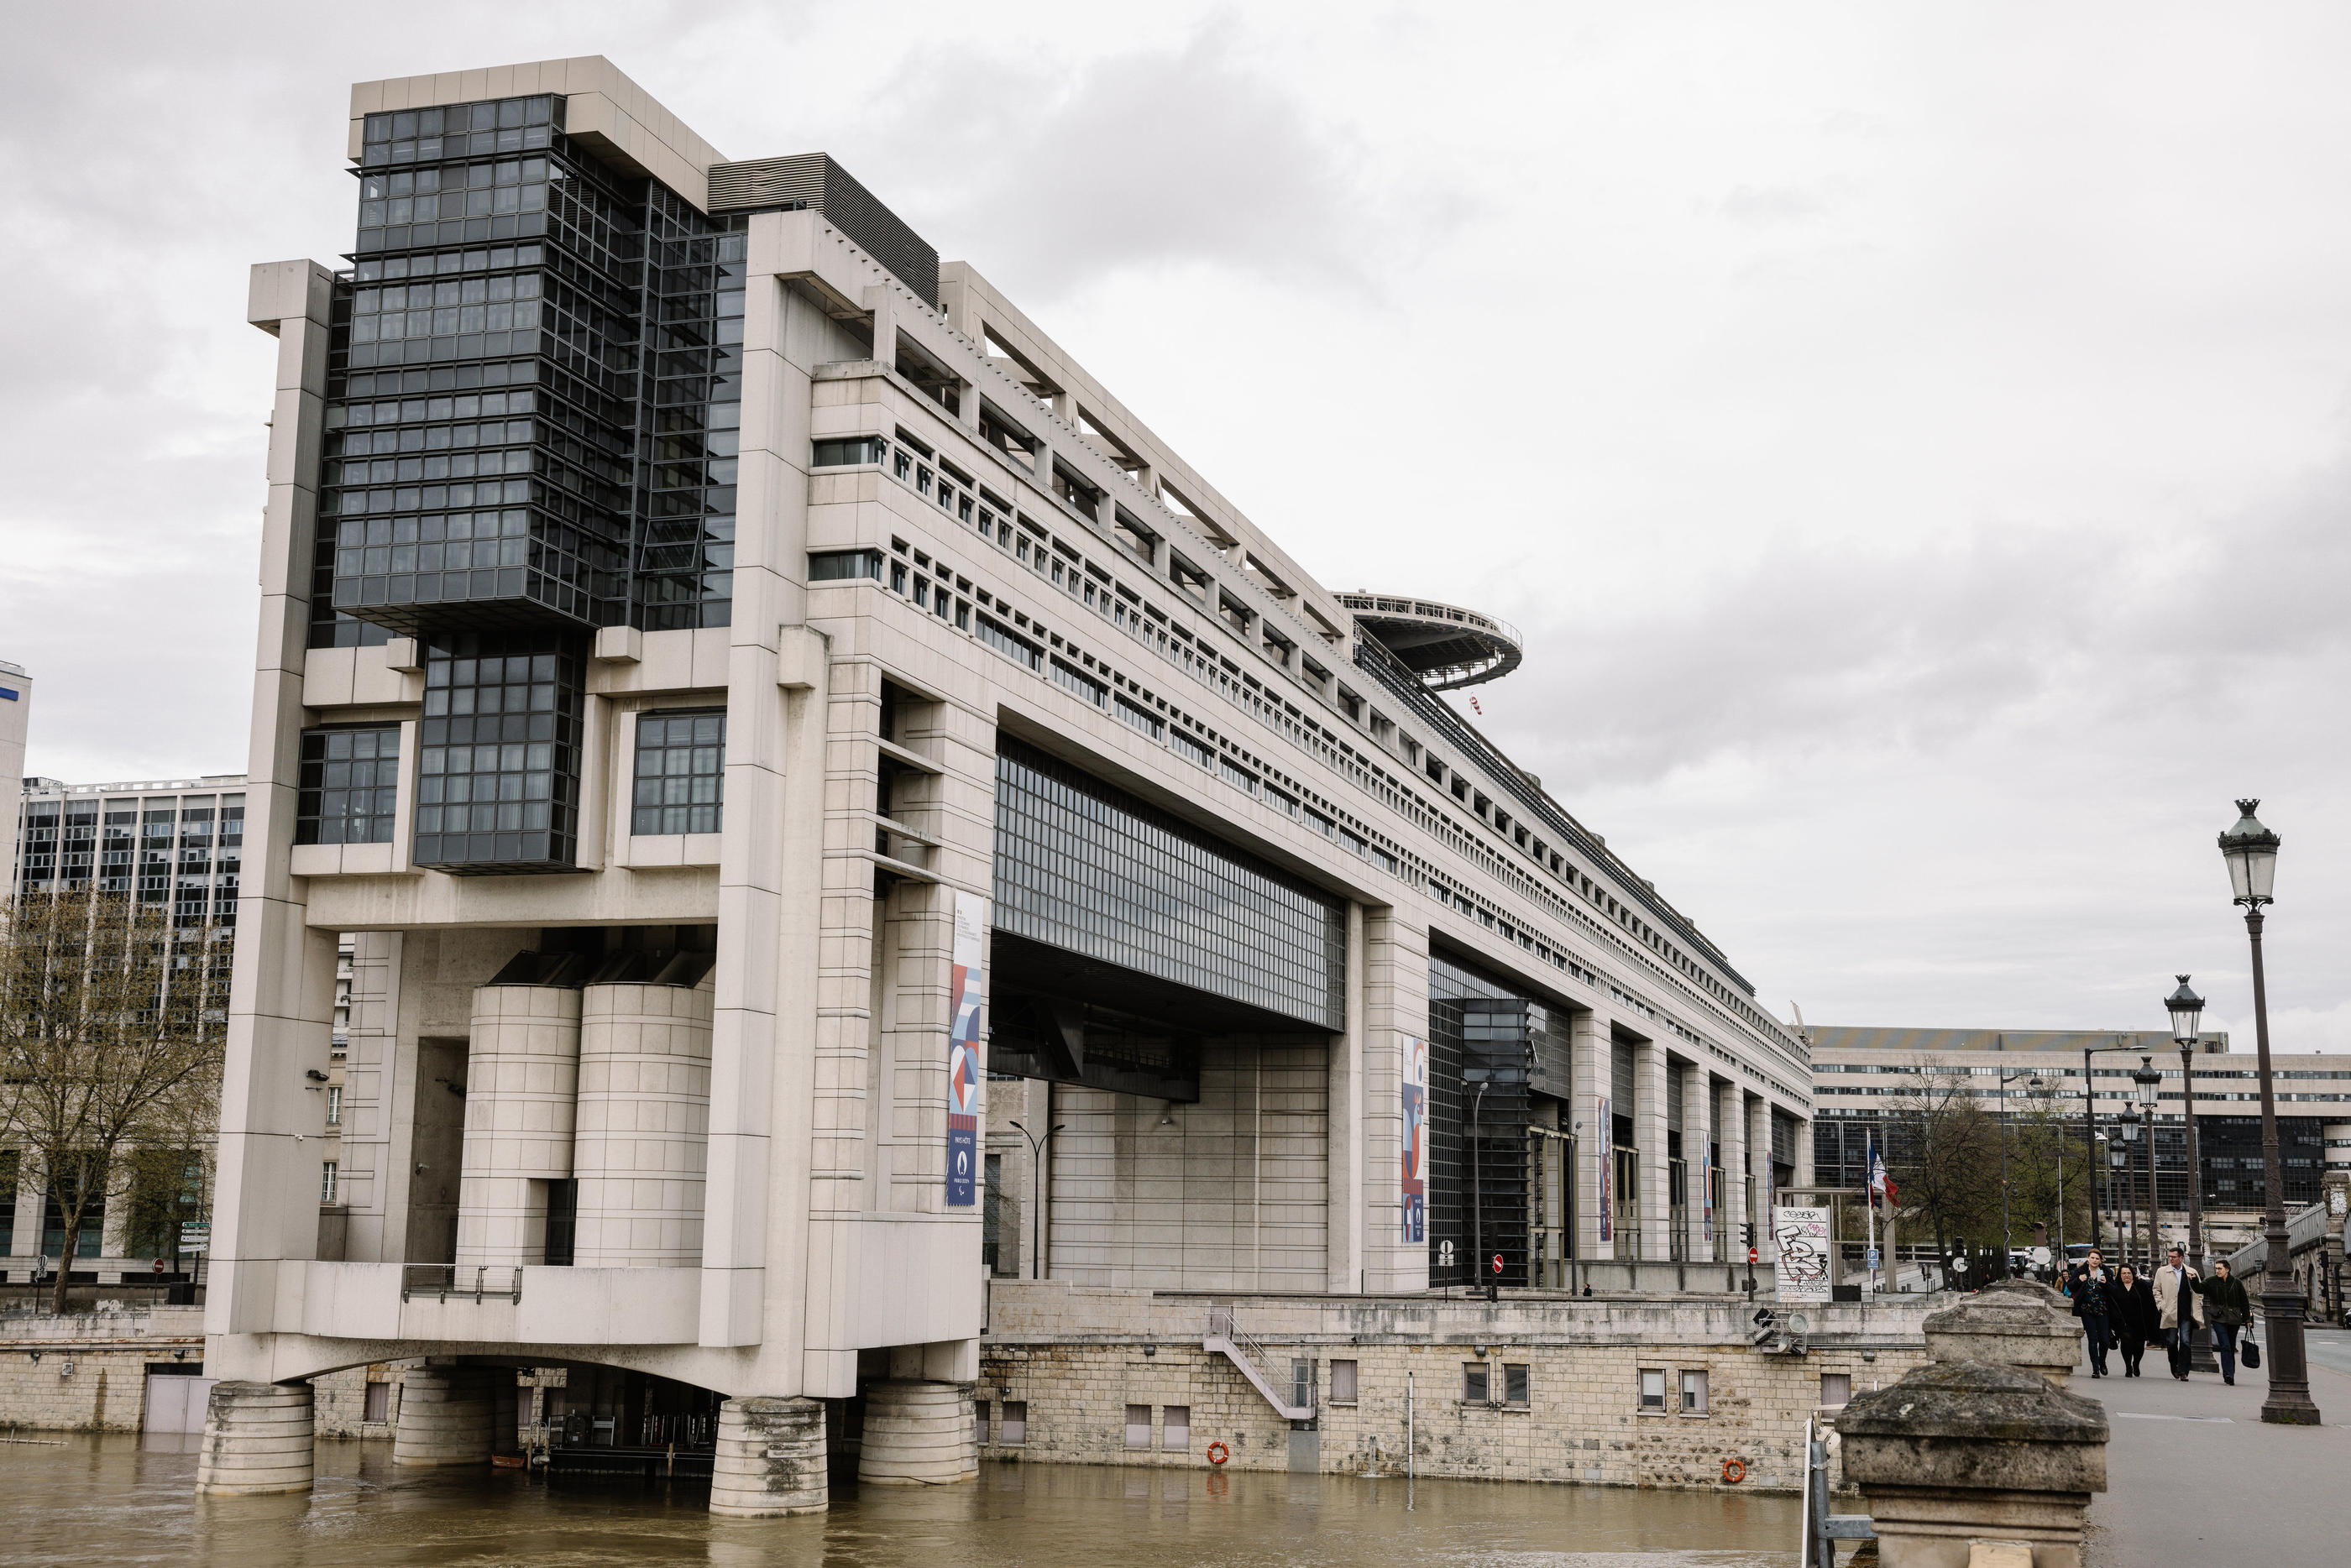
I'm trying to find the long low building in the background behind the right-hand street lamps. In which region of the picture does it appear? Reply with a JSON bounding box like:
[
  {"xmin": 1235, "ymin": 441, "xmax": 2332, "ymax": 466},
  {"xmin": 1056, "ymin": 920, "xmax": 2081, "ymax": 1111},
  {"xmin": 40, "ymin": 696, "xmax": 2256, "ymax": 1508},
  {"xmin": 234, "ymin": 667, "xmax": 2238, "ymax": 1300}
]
[{"xmin": 1805, "ymin": 1025, "xmax": 2351, "ymax": 1253}]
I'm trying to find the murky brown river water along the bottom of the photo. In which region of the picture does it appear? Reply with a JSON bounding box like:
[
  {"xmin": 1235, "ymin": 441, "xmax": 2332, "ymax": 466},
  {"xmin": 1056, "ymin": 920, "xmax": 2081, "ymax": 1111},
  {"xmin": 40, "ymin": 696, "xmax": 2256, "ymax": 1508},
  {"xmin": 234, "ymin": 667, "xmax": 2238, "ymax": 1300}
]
[{"xmin": 0, "ymin": 1436, "xmax": 1796, "ymax": 1568}]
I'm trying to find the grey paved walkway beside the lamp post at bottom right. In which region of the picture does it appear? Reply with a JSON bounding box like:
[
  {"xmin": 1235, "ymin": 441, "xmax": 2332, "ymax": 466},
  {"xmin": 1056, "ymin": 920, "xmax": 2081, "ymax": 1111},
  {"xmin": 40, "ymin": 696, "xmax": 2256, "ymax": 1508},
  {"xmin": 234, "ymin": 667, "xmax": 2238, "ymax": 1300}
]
[{"xmin": 2069, "ymin": 1330, "xmax": 2351, "ymax": 1568}]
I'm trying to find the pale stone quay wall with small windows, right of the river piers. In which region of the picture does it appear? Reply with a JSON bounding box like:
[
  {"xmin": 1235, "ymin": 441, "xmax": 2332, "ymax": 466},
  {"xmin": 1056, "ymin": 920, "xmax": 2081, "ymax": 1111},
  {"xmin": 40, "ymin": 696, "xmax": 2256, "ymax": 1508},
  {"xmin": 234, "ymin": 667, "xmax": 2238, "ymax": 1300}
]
[{"xmin": 973, "ymin": 1281, "xmax": 1925, "ymax": 1491}]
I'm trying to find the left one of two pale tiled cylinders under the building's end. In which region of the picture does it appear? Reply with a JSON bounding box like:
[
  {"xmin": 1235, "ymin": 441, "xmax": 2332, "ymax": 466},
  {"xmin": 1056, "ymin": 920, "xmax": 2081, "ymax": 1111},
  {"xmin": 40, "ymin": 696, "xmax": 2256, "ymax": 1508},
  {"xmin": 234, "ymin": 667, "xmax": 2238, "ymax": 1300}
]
[{"xmin": 456, "ymin": 985, "xmax": 581, "ymax": 1265}]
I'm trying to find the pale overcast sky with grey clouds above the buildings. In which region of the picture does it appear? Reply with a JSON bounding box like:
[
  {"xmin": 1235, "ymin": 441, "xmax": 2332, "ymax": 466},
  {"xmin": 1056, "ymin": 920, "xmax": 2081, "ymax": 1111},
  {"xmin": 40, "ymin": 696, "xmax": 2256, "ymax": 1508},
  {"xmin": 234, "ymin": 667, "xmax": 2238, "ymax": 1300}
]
[{"xmin": 0, "ymin": 0, "xmax": 2351, "ymax": 1048}]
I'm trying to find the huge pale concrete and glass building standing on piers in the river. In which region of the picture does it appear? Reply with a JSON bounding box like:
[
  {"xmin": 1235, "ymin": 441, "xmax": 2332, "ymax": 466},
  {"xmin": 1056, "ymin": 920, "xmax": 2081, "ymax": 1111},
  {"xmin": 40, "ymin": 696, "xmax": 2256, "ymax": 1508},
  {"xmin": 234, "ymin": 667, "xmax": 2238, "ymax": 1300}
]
[{"xmin": 202, "ymin": 59, "xmax": 1813, "ymax": 1512}]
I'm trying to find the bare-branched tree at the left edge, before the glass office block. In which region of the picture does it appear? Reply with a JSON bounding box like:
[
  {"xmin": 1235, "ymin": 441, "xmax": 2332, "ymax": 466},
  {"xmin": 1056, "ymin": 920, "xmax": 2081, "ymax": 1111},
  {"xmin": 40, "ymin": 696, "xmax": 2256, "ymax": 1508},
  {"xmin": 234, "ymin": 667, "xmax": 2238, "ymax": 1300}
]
[{"xmin": 0, "ymin": 891, "xmax": 228, "ymax": 1312}]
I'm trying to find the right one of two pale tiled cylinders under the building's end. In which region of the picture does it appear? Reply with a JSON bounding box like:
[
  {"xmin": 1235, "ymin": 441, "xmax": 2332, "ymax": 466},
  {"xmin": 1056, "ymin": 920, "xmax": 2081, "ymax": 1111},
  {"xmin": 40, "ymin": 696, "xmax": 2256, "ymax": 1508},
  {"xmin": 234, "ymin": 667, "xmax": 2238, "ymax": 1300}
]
[{"xmin": 571, "ymin": 983, "xmax": 712, "ymax": 1269}]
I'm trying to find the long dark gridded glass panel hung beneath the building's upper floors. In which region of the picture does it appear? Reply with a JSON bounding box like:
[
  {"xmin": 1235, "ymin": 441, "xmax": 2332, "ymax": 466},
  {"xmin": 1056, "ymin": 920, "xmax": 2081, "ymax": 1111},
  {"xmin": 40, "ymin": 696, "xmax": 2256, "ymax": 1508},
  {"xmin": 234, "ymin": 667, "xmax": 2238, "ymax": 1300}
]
[{"xmin": 994, "ymin": 738, "xmax": 1347, "ymax": 1032}]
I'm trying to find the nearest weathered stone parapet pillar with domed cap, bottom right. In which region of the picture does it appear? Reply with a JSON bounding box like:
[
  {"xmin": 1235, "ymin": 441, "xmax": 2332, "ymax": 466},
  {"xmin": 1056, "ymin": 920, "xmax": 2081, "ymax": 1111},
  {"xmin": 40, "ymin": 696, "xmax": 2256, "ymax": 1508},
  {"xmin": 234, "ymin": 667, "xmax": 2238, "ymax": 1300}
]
[{"xmin": 1836, "ymin": 1362, "xmax": 2107, "ymax": 1568}]
